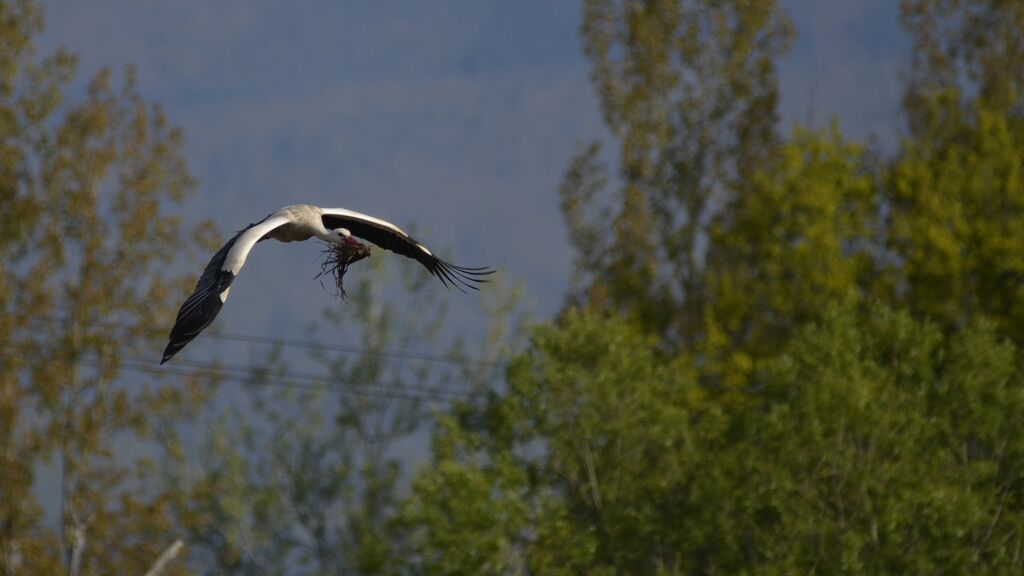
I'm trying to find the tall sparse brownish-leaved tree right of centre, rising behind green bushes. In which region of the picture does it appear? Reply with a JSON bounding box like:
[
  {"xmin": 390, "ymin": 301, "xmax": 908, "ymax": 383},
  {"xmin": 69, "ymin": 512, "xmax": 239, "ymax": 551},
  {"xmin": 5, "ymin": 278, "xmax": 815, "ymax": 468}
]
[{"xmin": 560, "ymin": 0, "xmax": 792, "ymax": 342}]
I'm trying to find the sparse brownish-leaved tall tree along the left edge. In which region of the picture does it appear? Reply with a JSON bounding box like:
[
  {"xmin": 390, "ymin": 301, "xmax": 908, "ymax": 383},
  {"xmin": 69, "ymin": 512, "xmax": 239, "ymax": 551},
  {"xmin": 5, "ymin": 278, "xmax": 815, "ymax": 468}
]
[{"xmin": 0, "ymin": 0, "xmax": 214, "ymax": 574}]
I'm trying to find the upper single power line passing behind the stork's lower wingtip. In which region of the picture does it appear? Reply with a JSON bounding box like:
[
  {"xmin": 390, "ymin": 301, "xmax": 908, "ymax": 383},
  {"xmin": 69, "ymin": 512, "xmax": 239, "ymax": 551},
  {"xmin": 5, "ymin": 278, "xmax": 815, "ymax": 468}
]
[{"xmin": 0, "ymin": 313, "xmax": 505, "ymax": 368}]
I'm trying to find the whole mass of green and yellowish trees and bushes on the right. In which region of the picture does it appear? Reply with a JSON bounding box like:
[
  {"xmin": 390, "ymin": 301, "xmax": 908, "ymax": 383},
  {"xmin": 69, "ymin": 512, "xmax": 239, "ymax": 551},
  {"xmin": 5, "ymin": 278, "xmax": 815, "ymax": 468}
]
[{"xmin": 402, "ymin": 0, "xmax": 1024, "ymax": 574}]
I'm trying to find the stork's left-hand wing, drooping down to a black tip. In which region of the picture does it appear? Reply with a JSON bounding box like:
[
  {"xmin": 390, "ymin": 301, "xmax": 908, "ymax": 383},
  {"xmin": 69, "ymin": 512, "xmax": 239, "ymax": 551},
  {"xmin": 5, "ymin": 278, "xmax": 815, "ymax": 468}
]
[{"xmin": 160, "ymin": 215, "xmax": 289, "ymax": 364}]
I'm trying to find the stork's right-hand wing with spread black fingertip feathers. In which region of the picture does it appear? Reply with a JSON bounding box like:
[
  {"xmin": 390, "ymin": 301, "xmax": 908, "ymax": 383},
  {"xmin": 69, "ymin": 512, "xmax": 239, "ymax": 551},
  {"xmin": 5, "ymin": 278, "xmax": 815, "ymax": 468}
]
[{"xmin": 321, "ymin": 208, "xmax": 495, "ymax": 291}]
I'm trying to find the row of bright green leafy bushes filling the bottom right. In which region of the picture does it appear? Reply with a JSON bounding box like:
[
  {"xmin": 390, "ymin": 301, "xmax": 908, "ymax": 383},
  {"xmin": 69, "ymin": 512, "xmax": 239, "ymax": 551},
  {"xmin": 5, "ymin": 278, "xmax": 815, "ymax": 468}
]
[{"xmin": 404, "ymin": 306, "xmax": 1024, "ymax": 574}]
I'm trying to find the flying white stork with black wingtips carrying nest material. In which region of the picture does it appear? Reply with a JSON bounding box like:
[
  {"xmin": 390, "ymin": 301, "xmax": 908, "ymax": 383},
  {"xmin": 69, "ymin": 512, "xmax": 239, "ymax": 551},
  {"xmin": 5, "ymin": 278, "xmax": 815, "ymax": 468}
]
[{"xmin": 160, "ymin": 204, "xmax": 495, "ymax": 364}]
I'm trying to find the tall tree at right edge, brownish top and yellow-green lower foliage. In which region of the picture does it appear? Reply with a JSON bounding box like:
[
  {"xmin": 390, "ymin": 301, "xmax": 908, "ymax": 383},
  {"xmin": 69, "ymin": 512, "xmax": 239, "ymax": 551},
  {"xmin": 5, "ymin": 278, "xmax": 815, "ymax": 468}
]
[{"xmin": 884, "ymin": 0, "xmax": 1024, "ymax": 342}]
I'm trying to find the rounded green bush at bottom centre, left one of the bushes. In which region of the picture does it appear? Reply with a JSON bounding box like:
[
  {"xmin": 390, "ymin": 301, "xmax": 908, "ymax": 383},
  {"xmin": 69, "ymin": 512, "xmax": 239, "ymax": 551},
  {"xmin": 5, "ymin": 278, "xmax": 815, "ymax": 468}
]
[{"xmin": 404, "ymin": 314, "xmax": 699, "ymax": 574}]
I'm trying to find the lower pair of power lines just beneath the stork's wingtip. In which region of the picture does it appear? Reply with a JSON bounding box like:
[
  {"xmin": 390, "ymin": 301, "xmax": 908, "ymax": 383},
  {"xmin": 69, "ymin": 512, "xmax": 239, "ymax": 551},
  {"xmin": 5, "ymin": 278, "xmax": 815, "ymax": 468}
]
[{"xmin": 0, "ymin": 343, "xmax": 479, "ymax": 401}]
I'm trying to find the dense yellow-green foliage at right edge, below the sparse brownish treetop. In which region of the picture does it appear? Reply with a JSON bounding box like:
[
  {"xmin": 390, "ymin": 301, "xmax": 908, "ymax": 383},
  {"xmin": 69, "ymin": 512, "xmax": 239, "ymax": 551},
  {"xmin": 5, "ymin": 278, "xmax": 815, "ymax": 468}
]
[{"xmin": 887, "ymin": 109, "xmax": 1024, "ymax": 334}]
